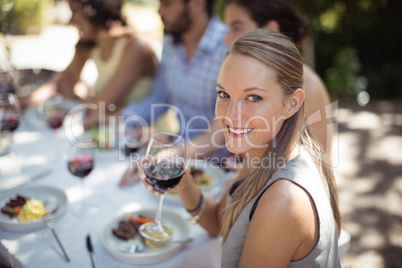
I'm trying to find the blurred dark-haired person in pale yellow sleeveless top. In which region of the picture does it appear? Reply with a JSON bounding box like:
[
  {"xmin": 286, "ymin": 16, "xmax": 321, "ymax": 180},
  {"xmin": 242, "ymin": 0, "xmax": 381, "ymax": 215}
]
[{"xmin": 32, "ymin": 0, "xmax": 174, "ymax": 128}]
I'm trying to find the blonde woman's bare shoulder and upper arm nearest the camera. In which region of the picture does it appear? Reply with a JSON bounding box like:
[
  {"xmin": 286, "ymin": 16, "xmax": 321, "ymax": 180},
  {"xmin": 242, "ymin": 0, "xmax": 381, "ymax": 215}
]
[{"xmin": 239, "ymin": 180, "xmax": 318, "ymax": 267}]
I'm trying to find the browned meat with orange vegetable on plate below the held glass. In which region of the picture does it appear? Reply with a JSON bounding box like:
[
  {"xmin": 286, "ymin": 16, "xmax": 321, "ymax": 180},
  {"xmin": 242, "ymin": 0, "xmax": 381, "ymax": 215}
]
[{"xmin": 112, "ymin": 214, "xmax": 154, "ymax": 241}]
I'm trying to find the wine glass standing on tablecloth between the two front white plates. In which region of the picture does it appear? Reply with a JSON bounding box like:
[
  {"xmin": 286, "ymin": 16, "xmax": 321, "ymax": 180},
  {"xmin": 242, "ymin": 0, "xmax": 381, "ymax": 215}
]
[{"xmin": 67, "ymin": 138, "xmax": 99, "ymax": 217}]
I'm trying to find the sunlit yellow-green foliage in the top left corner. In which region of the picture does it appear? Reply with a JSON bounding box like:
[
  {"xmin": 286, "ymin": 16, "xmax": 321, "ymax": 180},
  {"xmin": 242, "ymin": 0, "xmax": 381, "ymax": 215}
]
[{"xmin": 0, "ymin": 0, "xmax": 53, "ymax": 34}]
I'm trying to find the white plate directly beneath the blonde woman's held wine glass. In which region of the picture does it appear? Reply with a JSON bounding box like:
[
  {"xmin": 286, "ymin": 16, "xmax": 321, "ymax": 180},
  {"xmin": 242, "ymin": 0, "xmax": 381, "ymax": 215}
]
[{"xmin": 102, "ymin": 208, "xmax": 189, "ymax": 264}]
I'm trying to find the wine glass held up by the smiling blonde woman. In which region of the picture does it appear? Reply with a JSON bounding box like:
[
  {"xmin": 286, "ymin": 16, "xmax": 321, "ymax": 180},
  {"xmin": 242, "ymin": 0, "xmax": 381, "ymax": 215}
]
[{"xmin": 139, "ymin": 133, "xmax": 186, "ymax": 242}]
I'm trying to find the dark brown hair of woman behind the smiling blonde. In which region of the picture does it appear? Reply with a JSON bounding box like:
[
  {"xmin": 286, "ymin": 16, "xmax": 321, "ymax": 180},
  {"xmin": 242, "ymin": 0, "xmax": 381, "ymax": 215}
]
[{"xmin": 226, "ymin": 0, "xmax": 308, "ymax": 45}]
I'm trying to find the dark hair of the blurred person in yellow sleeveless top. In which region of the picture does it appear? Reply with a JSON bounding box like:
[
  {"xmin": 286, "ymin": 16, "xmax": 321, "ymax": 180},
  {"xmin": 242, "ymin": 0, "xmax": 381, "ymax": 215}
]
[{"xmin": 81, "ymin": 0, "xmax": 127, "ymax": 29}]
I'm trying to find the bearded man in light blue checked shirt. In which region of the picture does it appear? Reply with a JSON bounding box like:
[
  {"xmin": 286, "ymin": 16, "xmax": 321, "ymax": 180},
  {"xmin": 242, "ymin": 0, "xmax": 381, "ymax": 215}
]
[{"xmin": 120, "ymin": 0, "xmax": 227, "ymax": 185}]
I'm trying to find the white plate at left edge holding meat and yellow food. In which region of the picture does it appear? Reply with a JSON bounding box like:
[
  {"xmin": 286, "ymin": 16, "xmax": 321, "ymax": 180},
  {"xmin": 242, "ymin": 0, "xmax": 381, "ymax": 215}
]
[{"xmin": 0, "ymin": 186, "xmax": 68, "ymax": 233}]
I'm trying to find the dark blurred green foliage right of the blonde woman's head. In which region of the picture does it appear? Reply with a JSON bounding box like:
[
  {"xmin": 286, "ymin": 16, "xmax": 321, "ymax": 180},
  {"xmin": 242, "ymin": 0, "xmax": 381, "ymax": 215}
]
[{"xmin": 292, "ymin": 0, "xmax": 402, "ymax": 99}]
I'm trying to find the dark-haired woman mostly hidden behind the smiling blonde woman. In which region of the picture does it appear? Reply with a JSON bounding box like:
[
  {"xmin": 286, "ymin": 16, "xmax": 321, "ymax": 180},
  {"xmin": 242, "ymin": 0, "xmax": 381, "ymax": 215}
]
[{"xmin": 224, "ymin": 0, "xmax": 334, "ymax": 161}]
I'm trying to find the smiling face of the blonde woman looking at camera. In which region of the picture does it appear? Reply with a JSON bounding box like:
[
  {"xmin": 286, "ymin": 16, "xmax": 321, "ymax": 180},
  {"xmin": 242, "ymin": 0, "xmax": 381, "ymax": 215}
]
[{"xmin": 215, "ymin": 55, "xmax": 291, "ymax": 156}]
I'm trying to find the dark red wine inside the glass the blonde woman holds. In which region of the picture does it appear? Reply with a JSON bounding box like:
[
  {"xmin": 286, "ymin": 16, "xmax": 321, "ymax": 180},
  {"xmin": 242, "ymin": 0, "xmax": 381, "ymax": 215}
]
[{"xmin": 145, "ymin": 162, "xmax": 184, "ymax": 193}]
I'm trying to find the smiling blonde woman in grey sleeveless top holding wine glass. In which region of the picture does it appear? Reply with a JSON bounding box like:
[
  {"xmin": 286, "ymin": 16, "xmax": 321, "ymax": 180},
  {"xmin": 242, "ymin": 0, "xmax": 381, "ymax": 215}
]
[{"xmin": 141, "ymin": 29, "xmax": 341, "ymax": 268}]
